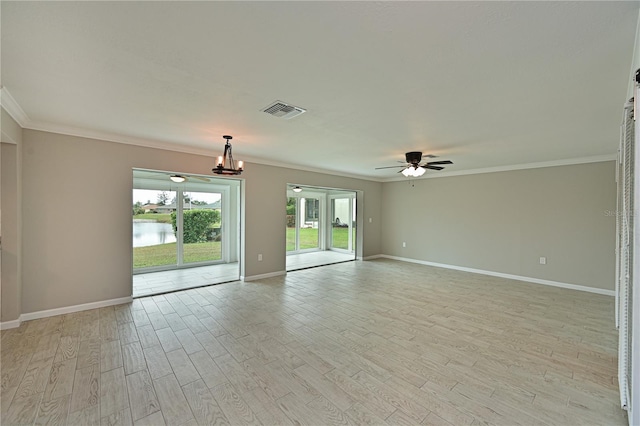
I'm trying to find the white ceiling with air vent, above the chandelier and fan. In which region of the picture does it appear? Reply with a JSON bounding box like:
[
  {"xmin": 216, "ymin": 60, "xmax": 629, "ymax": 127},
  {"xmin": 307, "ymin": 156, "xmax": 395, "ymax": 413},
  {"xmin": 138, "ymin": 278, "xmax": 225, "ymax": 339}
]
[{"xmin": 0, "ymin": 1, "xmax": 640, "ymax": 179}]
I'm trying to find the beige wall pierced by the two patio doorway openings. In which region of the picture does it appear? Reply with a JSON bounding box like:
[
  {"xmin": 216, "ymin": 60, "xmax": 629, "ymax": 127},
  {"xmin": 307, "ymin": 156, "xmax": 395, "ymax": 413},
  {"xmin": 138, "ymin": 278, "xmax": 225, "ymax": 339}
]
[{"xmin": 22, "ymin": 130, "xmax": 382, "ymax": 313}]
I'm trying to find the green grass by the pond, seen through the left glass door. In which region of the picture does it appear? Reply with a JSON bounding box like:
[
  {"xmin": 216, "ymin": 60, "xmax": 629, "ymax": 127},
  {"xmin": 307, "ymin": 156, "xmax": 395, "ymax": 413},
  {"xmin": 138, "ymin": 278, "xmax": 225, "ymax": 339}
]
[{"xmin": 133, "ymin": 241, "xmax": 222, "ymax": 268}]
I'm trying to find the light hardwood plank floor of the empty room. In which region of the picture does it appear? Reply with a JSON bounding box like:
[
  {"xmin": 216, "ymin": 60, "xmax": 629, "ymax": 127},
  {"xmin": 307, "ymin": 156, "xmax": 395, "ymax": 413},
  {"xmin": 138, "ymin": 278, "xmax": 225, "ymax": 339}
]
[{"xmin": 1, "ymin": 260, "xmax": 627, "ymax": 425}]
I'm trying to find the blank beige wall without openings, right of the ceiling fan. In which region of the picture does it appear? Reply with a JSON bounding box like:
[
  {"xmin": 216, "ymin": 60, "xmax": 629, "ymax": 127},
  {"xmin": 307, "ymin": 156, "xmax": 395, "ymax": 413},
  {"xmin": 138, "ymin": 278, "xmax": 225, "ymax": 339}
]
[{"xmin": 382, "ymin": 161, "xmax": 616, "ymax": 290}]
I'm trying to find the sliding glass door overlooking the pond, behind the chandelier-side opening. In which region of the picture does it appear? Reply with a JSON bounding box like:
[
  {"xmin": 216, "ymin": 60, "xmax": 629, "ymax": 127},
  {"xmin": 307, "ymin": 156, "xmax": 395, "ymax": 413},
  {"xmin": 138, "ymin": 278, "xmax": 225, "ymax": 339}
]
[{"xmin": 133, "ymin": 170, "xmax": 240, "ymax": 273}]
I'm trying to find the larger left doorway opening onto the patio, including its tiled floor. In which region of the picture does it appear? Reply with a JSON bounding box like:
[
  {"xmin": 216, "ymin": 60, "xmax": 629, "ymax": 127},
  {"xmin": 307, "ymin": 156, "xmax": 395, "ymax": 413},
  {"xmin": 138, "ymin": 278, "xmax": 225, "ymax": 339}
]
[{"xmin": 132, "ymin": 169, "xmax": 240, "ymax": 297}]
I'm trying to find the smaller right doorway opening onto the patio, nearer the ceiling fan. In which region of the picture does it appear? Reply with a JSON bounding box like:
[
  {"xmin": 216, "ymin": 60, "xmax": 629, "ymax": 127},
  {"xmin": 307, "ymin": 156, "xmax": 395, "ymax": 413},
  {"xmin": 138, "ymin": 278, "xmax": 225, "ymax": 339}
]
[{"xmin": 286, "ymin": 185, "xmax": 357, "ymax": 271}]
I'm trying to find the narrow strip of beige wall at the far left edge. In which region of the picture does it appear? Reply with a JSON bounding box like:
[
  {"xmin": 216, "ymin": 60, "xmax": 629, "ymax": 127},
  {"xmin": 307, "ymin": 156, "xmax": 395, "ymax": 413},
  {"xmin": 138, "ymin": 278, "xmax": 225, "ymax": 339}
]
[{"xmin": 0, "ymin": 109, "xmax": 22, "ymax": 322}]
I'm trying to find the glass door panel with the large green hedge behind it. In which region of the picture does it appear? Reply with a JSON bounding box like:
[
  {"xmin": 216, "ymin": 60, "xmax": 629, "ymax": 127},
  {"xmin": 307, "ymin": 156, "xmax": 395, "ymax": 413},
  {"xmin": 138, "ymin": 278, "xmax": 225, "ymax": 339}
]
[{"xmin": 182, "ymin": 192, "xmax": 223, "ymax": 263}]
